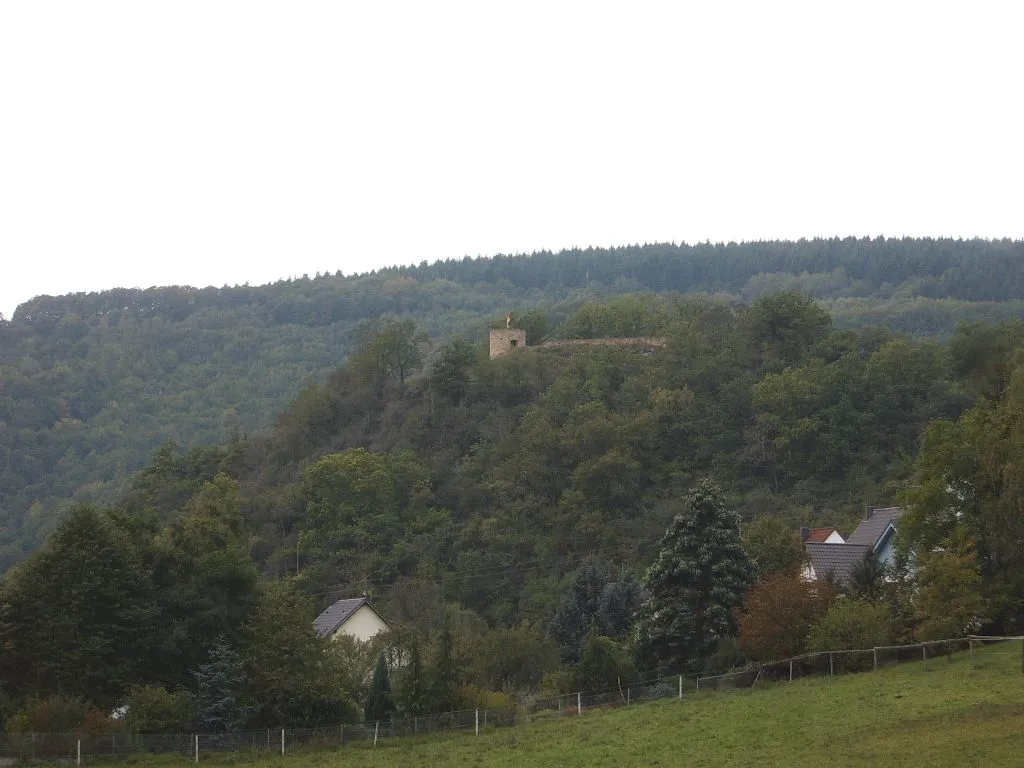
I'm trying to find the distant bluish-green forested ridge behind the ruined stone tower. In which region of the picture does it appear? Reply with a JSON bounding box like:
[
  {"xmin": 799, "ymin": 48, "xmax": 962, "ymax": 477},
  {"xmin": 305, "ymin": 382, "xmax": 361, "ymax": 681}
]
[{"xmin": 0, "ymin": 239, "xmax": 1024, "ymax": 571}]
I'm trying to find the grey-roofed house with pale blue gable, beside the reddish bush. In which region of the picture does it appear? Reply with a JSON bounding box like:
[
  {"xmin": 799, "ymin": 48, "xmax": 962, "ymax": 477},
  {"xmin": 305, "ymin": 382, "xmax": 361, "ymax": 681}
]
[{"xmin": 804, "ymin": 507, "xmax": 903, "ymax": 587}]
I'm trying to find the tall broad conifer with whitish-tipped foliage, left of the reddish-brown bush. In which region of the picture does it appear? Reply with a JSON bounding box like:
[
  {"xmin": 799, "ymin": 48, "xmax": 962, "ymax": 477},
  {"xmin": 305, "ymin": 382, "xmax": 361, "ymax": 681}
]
[{"xmin": 636, "ymin": 479, "xmax": 755, "ymax": 672}]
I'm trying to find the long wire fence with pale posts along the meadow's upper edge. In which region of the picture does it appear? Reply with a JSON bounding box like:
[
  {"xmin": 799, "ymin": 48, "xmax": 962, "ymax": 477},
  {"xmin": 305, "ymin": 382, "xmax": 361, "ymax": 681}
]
[{"xmin": 0, "ymin": 636, "xmax": 1024, "ymax": 766}]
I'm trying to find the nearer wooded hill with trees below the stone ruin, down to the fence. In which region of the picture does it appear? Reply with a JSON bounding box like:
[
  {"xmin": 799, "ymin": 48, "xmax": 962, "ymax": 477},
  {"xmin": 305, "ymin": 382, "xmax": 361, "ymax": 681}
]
[{"xmin": 0, "ymin": 292, "xmax": 1024, "ymax": 732}]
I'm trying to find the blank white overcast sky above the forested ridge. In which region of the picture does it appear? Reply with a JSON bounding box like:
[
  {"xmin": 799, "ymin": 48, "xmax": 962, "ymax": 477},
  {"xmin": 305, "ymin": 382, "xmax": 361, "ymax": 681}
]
[{"xmin": 0, "ymin": 0, "xmax": 1024, "ymax": 316}]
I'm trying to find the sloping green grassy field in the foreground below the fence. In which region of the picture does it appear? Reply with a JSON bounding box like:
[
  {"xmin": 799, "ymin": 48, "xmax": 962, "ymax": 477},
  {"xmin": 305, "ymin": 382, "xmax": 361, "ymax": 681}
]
[{"xmin": 121, "ymin": 646, "xmax": 1024, "ymax": 768}]
